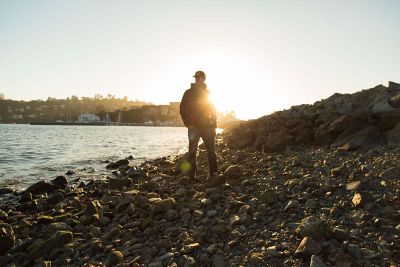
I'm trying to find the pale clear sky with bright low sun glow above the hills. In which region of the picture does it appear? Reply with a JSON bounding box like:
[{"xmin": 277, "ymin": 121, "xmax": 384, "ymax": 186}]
[{"xmin": 0, "ymin": 0, "xmax": 400, "ymax": 119}]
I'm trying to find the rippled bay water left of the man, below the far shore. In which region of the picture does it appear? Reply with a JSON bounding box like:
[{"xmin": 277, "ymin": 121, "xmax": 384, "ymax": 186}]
[{"xmin": 0, "ymin": 124, "xmax": 187, "ymax": 190}]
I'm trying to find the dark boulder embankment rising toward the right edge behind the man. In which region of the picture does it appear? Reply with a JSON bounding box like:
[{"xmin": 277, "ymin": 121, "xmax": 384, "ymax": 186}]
[{"xmin": 226, "ymin": 82, "xmax": 400, "ymax": 151}]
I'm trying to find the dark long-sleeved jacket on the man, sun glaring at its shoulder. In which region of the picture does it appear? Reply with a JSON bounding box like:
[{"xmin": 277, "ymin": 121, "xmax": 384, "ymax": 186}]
[{"xmin": 180, "ymin": 83, "xmax": 217, "ymax": 129}]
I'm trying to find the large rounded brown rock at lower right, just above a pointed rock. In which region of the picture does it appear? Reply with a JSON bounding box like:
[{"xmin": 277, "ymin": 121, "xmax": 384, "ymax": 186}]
[{"xmin": 296, "ymin": 216, "xmax": 331, "ymax": 240}]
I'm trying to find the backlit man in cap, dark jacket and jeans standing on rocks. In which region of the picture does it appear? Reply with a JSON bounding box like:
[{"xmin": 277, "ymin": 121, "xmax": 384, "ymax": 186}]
[{"xmin": 180, "ymin": 71, "xmax": 217, "ymax": 178}]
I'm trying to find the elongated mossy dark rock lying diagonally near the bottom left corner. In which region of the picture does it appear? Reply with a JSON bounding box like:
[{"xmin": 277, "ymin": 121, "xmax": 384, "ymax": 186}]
[{"xmin": 28, "ymin": 231, "xmax": 73, "ymax": 260}]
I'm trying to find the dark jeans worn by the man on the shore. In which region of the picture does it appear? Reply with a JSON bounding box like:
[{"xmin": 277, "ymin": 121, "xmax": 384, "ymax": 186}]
[{"xmin": 188, "ymin": 126, "xmax": 217, "ymax": 176}]
